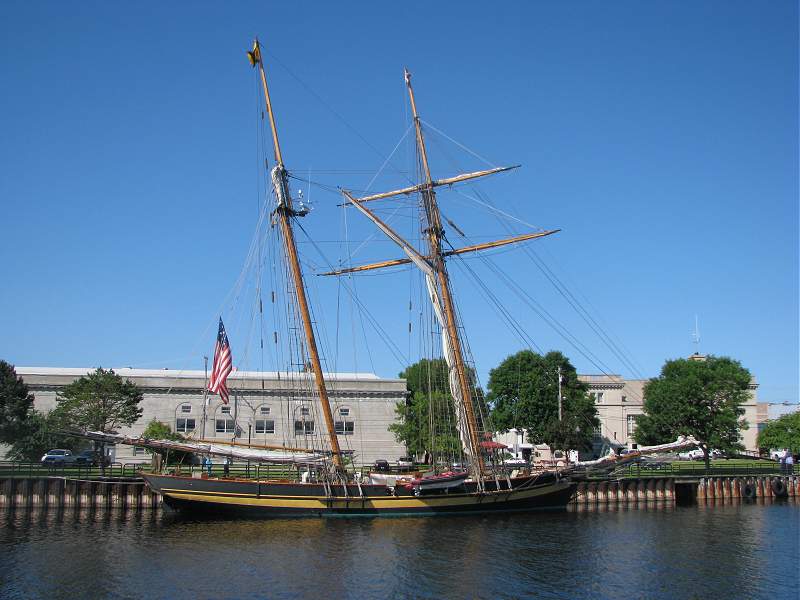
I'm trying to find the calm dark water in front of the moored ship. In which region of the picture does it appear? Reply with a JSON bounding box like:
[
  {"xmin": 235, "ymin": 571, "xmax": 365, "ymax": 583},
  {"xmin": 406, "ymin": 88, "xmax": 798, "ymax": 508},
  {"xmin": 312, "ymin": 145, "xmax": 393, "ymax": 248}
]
[{"xmin": 0, "ymin": 503, "xmax": 800, "ymax": 600}]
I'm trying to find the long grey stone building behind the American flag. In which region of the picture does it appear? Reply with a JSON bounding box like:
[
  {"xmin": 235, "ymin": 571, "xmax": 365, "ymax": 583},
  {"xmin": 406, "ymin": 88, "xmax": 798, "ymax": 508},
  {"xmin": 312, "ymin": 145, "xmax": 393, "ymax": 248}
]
[{"xmin": 16, "ymin": 367, "xmax": 406, "ymax": 464}]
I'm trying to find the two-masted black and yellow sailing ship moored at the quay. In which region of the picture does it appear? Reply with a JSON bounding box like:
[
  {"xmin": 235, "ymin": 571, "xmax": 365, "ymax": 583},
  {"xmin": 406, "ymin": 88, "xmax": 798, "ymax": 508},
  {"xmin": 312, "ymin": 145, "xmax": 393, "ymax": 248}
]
[{"xmin": 117, "ymin": 40, "xmax": 573, "ymax": 516}]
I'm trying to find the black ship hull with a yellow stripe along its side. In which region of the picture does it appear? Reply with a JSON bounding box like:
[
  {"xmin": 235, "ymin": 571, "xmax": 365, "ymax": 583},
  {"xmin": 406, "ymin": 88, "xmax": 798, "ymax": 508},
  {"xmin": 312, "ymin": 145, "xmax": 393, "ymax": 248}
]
[{"xmin": 143, "ymin": 474, "xmax": 574, "ymax": 517}]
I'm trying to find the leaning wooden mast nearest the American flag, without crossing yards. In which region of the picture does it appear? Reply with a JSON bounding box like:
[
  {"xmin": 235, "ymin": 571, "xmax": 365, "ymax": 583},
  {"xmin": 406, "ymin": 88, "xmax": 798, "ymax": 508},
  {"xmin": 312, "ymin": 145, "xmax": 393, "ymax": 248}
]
[{"xmin": 247, "ymin": 39, "xmax": 344, "ymax": 472}]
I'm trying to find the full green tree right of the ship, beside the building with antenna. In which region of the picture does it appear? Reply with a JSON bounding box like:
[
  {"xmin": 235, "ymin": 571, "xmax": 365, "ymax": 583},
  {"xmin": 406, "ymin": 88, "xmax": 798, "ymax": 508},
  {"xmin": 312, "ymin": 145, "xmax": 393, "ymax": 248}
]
[{"xmin": 634, "ymin": 356, "xmax": 751, "ymax": 468}]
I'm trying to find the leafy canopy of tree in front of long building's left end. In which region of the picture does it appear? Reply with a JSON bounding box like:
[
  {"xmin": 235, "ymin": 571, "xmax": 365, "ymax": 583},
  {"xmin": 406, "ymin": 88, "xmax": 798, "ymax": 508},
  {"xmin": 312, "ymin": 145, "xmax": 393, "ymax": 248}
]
[{"xmin": 55, "ymin": 368, "xmax": 143, "ymax": 433}]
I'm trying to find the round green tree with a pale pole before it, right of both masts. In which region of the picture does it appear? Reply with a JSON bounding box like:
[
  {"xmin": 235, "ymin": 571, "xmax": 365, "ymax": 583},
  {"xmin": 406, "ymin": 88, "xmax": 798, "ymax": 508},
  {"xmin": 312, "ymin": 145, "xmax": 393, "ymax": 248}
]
[{"xmin": 486, "ymin": 350, "xmax": 600, "ymax": 450}]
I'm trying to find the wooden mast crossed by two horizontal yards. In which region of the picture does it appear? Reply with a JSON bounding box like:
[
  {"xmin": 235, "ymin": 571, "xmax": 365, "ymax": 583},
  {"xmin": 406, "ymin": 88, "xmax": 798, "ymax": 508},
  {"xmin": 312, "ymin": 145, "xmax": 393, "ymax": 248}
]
[{"xmin": 404, "ymin": 69, "xmax": 484, "ymax": 480}]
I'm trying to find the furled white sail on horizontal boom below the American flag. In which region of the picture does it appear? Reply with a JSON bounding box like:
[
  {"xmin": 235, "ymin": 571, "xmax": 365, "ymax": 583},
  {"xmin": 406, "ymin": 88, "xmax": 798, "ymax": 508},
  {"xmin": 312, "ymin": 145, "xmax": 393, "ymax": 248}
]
[{"xmin": 81, "ymin": 431, "xmax": 328, "ymax": 464}]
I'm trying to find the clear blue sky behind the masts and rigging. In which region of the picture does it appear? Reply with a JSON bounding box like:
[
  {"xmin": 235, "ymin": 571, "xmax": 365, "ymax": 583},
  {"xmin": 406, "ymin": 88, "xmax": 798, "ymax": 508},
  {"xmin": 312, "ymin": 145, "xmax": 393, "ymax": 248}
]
[{"xmin": 0, "ymin": 1, "xmax": 799, "ymax": 402}]
